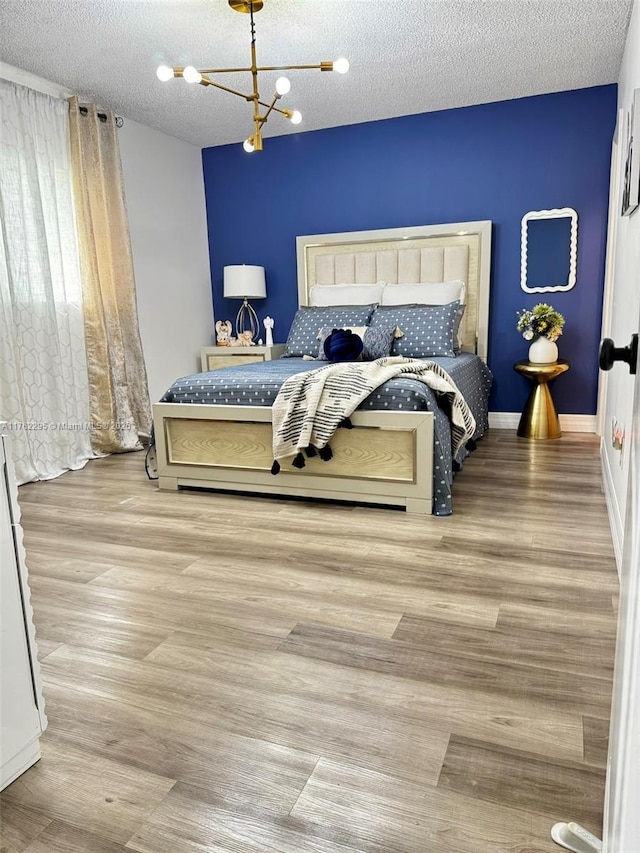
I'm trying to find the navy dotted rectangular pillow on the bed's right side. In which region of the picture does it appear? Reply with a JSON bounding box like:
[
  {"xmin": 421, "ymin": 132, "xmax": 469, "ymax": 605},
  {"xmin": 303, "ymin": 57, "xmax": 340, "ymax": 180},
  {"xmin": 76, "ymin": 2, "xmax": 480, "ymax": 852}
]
[{"xmin": 370, "ymin": 301, "xmax": 460, "ymax": 358}]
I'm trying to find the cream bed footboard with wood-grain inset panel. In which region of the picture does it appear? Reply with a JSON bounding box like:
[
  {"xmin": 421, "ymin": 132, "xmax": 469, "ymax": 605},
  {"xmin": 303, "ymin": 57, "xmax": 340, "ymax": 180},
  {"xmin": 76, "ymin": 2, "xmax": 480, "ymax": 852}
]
[{"xmin": 153, "ymin": 403, "xmax": 433, "ymax": 515}]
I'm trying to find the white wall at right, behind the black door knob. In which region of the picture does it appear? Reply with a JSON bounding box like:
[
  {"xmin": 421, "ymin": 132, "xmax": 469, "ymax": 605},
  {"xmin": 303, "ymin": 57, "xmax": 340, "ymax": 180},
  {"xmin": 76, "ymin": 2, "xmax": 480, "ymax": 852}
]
[{"xmin": 601, "ymin": 0, "xmax": 640, "ymax": 566}]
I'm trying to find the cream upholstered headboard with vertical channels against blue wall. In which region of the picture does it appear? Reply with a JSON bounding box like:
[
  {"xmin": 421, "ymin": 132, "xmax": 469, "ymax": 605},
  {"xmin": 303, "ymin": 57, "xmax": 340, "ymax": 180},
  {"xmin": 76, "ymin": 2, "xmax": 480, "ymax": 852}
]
[{"xmin": 296, "ymin": 220, "xmax": 491, "ymax": 361}]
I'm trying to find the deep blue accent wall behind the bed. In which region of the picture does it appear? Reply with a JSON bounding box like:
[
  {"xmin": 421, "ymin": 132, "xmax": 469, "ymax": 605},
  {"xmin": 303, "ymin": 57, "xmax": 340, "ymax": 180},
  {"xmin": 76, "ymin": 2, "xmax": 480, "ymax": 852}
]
[{"xmin": 202, "ymin": 85, "xmax": 617, "ymax": 414}]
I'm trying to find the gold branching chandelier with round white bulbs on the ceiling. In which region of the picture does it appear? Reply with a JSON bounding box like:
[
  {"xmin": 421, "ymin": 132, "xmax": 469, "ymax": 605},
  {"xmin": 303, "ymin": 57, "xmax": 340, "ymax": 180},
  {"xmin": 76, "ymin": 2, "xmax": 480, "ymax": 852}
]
[{"xmin": 156, "ymin": 0, "xmax": 349, "ymax": 153}]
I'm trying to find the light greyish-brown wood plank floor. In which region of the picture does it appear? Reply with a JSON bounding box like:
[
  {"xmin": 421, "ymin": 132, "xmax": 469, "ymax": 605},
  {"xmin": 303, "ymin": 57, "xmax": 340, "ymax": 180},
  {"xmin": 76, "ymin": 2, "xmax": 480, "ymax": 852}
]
[{"xmin": 0, "ymin": 431, "xmax": 617, "ymax": 853}]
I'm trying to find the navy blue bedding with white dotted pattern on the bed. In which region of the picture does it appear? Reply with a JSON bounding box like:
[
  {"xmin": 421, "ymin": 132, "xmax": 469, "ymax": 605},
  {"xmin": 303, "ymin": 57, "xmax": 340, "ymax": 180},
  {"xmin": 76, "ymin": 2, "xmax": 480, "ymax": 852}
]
[{"xmin": 160, "ymin": 353, "xmax": 493, "ymax": 515}]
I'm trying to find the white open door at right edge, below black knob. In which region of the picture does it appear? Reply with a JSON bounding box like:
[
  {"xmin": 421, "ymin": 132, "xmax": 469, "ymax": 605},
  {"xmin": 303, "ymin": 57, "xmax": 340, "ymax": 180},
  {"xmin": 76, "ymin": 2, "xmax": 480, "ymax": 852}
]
[{"xmin": 603, "ymin": 328, "xmax": 640, "ymax": 853}]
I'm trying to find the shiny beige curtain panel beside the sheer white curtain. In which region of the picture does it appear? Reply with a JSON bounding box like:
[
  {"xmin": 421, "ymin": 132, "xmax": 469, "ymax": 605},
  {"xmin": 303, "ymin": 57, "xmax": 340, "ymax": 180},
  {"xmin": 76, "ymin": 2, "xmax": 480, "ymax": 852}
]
[{"xmin": 69, "ymin": 98, "xmax": 151, "ymax": 453}]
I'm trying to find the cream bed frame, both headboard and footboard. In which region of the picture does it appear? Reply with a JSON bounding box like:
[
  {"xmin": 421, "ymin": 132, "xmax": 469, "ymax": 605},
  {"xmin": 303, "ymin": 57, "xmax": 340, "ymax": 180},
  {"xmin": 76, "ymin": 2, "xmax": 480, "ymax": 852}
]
[{"xmin": 153, "ymin": 220, "xmax": 491, "ymax": 515}]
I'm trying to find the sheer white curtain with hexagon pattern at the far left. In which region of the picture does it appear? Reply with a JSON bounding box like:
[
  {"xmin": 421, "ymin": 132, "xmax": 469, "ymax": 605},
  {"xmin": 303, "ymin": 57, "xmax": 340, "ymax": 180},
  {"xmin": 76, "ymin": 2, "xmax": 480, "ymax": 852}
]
[{"xmin": 0, "ymin": 79, "xmax": 95, "ymax": 483}]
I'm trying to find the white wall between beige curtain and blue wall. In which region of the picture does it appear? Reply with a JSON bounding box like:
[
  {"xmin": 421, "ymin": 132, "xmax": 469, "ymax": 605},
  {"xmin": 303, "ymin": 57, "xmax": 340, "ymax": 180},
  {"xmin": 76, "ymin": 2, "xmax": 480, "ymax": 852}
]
[{"xmin": 119, "ymin": 118, "xmax": 213, "ymax": 402}]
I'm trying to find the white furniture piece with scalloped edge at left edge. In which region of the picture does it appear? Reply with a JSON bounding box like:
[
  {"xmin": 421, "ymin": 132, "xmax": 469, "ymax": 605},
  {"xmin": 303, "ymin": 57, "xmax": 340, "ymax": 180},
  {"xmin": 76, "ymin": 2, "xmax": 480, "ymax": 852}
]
[{"xmin": 0, "ymin": 439, "xmax": 41, "ymax": 790}]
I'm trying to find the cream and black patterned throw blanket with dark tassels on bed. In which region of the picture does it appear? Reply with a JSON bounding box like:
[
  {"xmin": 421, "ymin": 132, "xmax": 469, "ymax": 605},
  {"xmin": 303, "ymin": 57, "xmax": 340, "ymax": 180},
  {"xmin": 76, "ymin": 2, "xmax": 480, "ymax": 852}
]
[{"xmin": 272, "ymin": 356, "xmax": 476, "ymax": 460}]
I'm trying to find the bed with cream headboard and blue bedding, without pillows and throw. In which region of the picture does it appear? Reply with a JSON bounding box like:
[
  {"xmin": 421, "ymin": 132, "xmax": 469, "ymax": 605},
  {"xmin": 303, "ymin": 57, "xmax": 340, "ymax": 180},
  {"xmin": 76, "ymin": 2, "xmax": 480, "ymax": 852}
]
[{"xmin": 153, "ymin": 221, "xmax": 491, "ymax": 515}]
